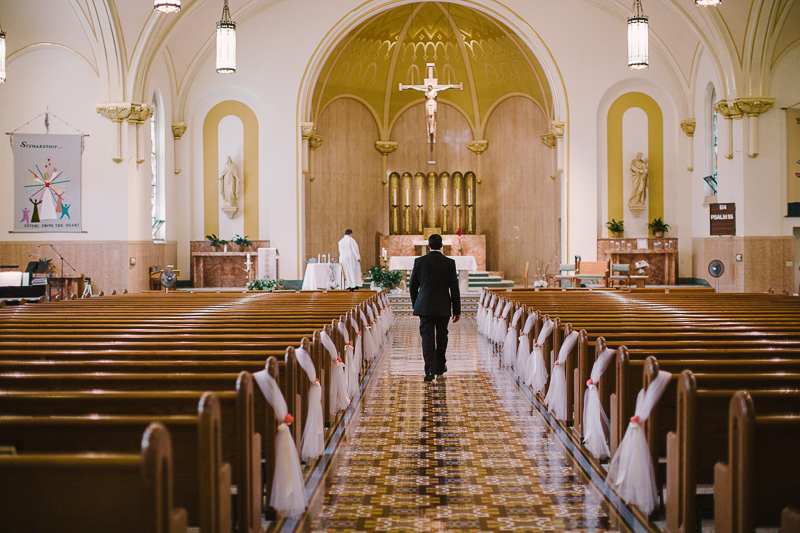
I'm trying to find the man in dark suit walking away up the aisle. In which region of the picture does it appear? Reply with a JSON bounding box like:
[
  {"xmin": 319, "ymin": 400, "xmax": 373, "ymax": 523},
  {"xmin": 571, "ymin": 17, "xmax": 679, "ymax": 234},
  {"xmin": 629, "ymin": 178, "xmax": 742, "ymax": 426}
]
[{"xmin": 409, "ymin": 233, "xmax": 461, "ymax": 381}]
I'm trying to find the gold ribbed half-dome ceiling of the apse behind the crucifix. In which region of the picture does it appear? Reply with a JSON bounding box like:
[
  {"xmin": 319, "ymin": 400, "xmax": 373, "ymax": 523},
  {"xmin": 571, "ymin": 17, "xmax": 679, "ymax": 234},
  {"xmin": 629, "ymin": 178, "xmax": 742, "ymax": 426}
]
[{"xmin": 312, "ymin": 2, "xmax": 551, "ymax": 135}]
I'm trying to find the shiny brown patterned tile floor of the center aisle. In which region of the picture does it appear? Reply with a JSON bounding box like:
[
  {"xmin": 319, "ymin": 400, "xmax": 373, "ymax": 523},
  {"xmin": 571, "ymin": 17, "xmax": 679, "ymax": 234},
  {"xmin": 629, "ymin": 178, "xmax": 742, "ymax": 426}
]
[{"xmin": 298, "ymin": 316, "xmax": 632, "ymax": 532}]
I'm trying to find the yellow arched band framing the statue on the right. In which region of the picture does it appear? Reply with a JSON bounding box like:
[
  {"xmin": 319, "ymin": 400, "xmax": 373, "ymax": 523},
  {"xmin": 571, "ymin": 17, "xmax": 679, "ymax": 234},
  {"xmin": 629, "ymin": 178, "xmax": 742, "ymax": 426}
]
[{"xmin": 607, "ymin": 92, "xmax": 664, "ymax": 231}]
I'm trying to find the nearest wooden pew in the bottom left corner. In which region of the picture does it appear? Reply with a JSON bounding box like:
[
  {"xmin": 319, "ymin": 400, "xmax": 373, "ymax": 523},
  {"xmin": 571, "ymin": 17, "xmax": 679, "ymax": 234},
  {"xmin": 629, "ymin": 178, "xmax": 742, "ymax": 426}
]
[{"xmin": 0, "ymin": 424, "xmax": 186, "ymax": 533}]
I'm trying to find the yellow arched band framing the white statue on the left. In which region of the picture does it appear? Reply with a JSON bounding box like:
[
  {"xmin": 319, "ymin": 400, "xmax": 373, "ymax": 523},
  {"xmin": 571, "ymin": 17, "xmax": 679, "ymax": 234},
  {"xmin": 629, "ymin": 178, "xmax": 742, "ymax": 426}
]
[{"xmin": 203, "ymin": 100, "xmax": 258, "ymax": 240}]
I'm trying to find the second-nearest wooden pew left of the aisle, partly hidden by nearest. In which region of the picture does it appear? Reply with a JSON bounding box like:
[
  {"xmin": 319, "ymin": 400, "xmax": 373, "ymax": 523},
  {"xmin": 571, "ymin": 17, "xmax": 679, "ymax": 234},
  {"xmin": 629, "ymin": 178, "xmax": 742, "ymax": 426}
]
[{"xmin": 0, "ymin": 392, "xmax": 231, "ymax": 533}]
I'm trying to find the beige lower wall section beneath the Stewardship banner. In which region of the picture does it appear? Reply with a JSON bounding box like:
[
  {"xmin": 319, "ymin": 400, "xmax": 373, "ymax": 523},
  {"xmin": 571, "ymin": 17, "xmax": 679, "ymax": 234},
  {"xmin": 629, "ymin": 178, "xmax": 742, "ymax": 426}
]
[{"xmin": 0, "ymin": 241, "xmax": 178, "ymax": 294}]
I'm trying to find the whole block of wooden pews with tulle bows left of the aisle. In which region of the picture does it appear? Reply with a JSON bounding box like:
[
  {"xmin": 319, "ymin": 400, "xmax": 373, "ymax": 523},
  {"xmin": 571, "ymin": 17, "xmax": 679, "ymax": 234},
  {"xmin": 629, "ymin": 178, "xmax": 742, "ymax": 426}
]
[{"xmin": 0, "ymin": 291, "xmax": 392, "ymax": 533}]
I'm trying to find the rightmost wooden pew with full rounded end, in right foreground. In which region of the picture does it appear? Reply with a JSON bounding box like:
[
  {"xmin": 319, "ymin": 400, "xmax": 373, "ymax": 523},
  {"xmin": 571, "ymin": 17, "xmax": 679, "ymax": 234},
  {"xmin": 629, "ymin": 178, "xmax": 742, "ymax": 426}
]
[{"xmin": 714, "ymin": 391, "xmax": 800, "ymax": 533}]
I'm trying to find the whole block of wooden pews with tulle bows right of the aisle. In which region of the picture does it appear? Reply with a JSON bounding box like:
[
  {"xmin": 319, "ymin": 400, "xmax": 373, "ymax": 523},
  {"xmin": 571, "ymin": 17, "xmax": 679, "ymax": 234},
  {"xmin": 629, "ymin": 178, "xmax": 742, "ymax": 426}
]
[{"xmin": 477, "ymin": 289, "xmax": 800, "ymax": 533}]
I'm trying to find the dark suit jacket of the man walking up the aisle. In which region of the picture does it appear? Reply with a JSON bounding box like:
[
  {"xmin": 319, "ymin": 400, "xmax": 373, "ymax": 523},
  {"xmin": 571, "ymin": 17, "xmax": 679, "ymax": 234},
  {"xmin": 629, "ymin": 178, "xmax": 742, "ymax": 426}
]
[{"xmin": 409, "ymin": 251, "xmax": 461, "ymax": 316}]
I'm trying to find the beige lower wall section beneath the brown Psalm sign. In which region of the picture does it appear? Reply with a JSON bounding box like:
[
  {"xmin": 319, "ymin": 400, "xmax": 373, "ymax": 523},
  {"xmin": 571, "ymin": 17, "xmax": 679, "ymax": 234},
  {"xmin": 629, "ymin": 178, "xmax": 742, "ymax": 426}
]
[{"xmin": 692, "ymin": 237, "xmax": 796, "ymax": 294}]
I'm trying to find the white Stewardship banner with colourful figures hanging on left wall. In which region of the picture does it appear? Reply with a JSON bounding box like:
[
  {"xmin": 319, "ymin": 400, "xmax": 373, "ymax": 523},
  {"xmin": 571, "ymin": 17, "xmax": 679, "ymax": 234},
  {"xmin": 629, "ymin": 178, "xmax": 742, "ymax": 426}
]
[{"xmin": 11, "ymin": 133, "xmax": 82, "ymax": 233}]
